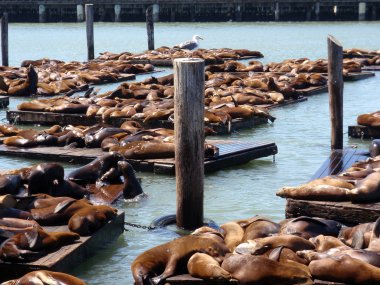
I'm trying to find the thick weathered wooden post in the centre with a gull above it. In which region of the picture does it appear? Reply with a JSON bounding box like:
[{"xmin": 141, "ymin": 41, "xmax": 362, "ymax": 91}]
[{"xmin": 174, "ymin": 58, "xmax": 205, "ymax": 230}]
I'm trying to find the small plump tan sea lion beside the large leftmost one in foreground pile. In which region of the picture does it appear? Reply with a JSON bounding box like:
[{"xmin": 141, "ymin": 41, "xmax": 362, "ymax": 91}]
[{"xmin": 187, "ymin": 252, "xmax": 232, "ymax": 279}]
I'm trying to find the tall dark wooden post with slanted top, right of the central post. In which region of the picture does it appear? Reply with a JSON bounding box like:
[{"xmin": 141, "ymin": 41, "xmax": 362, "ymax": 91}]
[{"xmin": 327, "ymin": 36, "xmax": 343, "ymax": 150}]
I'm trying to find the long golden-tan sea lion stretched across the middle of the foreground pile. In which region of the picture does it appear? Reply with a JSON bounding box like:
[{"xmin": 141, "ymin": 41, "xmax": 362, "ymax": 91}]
[{"xmin": 235, "ymin": 235, "xmax": 315, "ymax": 255}]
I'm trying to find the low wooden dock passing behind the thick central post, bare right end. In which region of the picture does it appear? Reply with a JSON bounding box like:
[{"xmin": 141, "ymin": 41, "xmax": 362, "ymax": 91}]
[{"xmin": 0, "ymin": 140, "xmax": 278, "ymax": 174}]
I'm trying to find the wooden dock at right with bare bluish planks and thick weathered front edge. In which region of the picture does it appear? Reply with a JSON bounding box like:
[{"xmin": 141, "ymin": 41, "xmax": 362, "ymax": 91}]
[{"xmin": 285, "ymin": 149, "xmax": 380, "ymax": 225}]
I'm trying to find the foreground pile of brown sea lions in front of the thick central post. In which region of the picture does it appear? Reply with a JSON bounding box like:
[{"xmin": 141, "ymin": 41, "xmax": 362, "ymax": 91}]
[{"xmin": 131, "ymin": 216, "xmax": 380, "ymax": 285}]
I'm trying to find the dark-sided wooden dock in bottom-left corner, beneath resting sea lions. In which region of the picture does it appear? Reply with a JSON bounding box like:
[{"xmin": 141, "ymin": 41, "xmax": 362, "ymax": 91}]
[{"xmin": 0, "ymin": 212, "xmax": 124, "ymax": 282}]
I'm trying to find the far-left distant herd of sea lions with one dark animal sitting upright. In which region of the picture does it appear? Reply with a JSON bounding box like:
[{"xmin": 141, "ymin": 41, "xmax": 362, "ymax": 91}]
[{"xmin": 0, "ymin": 59, "xmax": 154, "ymax": 97}]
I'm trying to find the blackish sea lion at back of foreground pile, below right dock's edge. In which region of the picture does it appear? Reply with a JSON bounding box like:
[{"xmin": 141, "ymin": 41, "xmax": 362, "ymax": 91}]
[{"xmin": 280, "ymin": 216, "xmax": 342, "ymax": 239}]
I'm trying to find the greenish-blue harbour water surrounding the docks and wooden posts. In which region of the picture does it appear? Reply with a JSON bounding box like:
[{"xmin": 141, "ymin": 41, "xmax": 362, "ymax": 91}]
[{"xmin": 0, "ymin": 22, "xmax": 380, "ymax": 284}]
